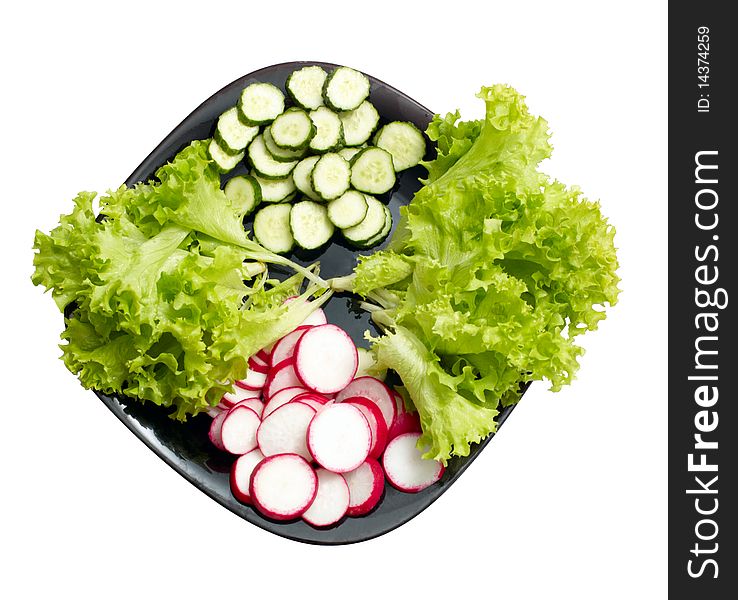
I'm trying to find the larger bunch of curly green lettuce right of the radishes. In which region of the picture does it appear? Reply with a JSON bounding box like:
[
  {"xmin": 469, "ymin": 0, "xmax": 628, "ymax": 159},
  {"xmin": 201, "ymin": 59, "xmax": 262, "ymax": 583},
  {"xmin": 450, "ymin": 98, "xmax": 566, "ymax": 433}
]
[{"xmin": 333, "ymin": 85, "xmax": 619, "ymax": 463}]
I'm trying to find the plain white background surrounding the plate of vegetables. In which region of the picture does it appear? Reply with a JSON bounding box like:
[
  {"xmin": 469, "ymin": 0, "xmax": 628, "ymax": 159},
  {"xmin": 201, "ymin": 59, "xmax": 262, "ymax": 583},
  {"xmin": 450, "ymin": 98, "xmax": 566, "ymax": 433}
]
[{"xmin": 0, "ymin": 0, "xmax": 667, "ymax": 600}]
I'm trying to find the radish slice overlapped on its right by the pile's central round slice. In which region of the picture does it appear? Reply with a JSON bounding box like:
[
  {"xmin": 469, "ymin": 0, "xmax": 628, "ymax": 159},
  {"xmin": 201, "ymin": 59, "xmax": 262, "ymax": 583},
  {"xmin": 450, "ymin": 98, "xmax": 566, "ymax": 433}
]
[{"xmin": 256, "ymin": 402, "xmax": 315, "ymax": 460}]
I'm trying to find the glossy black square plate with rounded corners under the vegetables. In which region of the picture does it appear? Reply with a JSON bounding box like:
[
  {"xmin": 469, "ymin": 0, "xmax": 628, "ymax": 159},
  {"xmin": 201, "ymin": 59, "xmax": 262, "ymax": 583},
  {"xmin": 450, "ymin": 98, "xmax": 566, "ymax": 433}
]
[{"xmin": 96, "ymin": 62, "xmax": 512, "ymax": 544}]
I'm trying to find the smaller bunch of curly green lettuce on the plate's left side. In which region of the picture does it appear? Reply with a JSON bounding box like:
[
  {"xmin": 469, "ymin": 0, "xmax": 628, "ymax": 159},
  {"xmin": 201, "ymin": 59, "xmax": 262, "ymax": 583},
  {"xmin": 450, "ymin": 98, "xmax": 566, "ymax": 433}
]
[{"xmin": 32, "ymin": 141, "xmax": 330, "ymax": 419}]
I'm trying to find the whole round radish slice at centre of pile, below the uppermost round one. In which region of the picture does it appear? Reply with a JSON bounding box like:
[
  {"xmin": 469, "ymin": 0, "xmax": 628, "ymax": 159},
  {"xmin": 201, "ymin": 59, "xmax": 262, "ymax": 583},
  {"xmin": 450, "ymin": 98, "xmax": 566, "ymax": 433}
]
[{"xmin": 308, "ymin": 403, "xmax": 372, "ymax": 473}]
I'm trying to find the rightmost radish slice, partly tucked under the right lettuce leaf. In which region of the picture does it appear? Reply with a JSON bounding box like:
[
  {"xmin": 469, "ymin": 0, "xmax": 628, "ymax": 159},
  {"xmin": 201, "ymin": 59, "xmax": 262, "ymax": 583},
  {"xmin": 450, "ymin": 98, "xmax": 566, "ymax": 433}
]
[{"xmin": 382, "ymin": 433, "xmax": 444, "ymax": 492}]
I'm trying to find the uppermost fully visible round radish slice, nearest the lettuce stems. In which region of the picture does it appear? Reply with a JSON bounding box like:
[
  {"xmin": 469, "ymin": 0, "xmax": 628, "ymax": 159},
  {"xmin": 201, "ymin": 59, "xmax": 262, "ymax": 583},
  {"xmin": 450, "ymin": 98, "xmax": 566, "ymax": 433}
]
[{"xmin": 295, "ymin": 325, "xmax": 359, "ymax": 394}]
